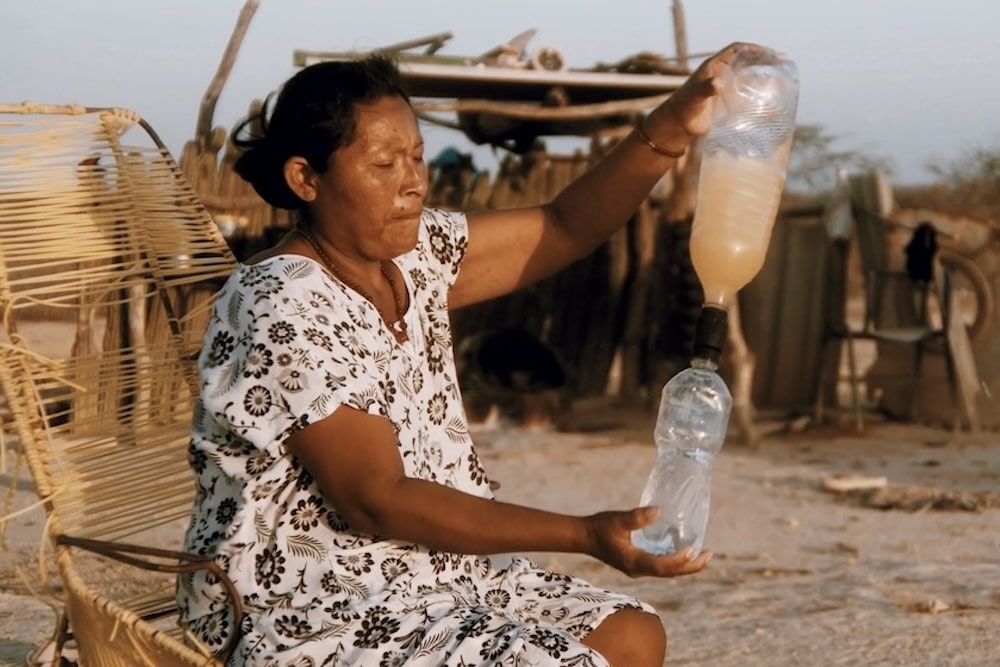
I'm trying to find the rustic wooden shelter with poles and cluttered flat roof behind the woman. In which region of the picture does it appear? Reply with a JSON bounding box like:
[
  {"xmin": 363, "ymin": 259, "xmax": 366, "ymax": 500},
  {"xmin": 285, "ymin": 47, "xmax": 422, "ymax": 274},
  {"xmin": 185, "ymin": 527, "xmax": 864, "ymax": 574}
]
[{"xmin": 181, "ymin": 0, "xmax": 756, "ymax": 442}]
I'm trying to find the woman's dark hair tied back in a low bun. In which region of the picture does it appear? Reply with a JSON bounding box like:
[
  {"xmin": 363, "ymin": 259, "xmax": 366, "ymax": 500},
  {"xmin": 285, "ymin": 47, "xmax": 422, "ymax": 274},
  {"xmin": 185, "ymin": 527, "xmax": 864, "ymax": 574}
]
[{"xmin": 231, "ymin": 53, "xmax": 410, "ymax": 210}]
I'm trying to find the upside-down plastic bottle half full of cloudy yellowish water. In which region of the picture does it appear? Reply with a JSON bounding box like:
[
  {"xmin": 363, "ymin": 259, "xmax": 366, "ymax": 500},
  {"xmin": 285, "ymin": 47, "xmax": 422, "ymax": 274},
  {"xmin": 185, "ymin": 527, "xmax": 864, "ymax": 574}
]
[{"xmin": 691, "ymin": 49, "xmax": 799, "ymax": 308}]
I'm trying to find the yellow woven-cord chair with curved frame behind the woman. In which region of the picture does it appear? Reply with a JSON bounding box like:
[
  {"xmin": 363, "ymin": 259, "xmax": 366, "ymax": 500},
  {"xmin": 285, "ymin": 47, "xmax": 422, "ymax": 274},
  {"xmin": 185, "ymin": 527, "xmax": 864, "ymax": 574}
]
[{"xmin": 0, "ymin": 105, "xmax": 241, "ymax": 667}]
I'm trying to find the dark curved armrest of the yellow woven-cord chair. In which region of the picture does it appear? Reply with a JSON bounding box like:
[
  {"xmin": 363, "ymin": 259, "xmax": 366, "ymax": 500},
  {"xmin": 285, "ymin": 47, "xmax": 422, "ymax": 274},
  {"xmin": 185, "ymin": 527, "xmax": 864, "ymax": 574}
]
[{"xmin": 56, "ymin": 535, "xmax": 243, "ymax": 664}]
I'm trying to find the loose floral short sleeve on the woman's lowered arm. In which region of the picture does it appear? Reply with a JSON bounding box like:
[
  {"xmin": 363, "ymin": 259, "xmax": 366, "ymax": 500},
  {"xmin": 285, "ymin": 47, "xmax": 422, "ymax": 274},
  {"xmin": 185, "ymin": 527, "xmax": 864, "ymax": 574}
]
[{"xmin": 201, "ymin": 257, "xmax": 387, "ymax": 451}]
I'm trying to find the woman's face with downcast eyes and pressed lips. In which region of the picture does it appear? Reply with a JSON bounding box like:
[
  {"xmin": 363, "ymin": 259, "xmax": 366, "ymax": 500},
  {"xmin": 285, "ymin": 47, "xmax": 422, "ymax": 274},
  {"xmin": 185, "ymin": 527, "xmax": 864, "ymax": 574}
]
[{"xmin": 312, "ymin": 96, "xmax": 427, "ymax": 260}]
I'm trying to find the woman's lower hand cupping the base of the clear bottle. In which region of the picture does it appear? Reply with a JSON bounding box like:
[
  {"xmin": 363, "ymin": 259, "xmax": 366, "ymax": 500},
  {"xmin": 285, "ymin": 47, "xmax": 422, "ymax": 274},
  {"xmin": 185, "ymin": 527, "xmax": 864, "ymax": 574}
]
[{"xmin": 585, "ymin": 507, "xmax": 712, "ymax": 577}]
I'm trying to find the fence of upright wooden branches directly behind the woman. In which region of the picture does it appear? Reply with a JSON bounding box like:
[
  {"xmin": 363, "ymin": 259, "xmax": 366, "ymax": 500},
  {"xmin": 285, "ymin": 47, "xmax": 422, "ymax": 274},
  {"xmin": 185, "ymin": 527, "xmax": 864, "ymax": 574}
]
[{"xmin": 180, "ymin": 131, "xmax": 701, "ymax": 402}]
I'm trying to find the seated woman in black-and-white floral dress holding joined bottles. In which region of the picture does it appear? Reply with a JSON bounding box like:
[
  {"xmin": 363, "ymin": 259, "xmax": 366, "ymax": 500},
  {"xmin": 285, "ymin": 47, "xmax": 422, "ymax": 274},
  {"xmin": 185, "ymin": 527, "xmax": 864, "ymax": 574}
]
[{"xmin": 178, "ymin": 44, "xmax": 756, "ymax": 667}]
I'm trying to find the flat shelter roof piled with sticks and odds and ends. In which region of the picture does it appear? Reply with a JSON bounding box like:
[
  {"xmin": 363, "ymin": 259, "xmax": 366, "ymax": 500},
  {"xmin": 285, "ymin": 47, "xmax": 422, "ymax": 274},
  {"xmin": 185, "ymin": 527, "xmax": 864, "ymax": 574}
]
[{"xmin": 293, "ymin": 30, "xmax": 689, "ymax": 153}]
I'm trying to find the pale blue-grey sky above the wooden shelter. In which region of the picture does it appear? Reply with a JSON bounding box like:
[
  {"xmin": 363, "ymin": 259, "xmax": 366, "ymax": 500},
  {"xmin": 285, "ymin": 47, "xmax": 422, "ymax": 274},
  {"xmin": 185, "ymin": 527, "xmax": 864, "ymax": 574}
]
[{"xmin": 0, "ymin": 0, "xmax": 1000, "ymax": 185}]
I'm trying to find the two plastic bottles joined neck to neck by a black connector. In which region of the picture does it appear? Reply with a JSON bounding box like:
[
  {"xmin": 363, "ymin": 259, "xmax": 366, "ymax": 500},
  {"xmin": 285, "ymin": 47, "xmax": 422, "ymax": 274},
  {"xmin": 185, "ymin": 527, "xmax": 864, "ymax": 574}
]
[{"xmin": 632, "ymin": 49, "xmax": 799, "ymax": 554}]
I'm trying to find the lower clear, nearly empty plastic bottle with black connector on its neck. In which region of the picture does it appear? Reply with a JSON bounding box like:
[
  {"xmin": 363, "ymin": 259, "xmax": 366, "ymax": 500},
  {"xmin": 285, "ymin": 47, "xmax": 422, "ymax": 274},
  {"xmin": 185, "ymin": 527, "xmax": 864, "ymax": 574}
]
[{"xmin": 632, "ymin": 306, "xmax": 733, "ymax": 554}]
